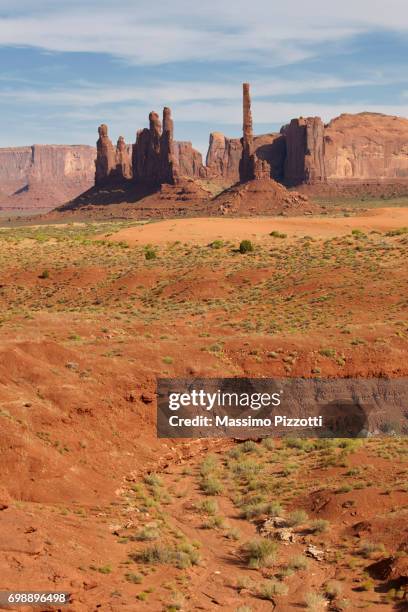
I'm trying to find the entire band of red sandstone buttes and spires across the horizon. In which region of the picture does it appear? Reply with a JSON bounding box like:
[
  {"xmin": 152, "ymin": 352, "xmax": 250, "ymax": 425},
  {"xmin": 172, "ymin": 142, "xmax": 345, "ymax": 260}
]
[{"xmin": 0, "ymin": 84, "xmax": 408, "ymax": 208}]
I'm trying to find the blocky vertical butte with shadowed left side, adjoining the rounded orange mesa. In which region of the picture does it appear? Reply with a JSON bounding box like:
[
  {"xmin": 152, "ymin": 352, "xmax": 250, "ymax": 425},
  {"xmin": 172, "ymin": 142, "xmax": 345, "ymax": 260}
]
[{"xmin": 282, "ymin": 117, "xmax": 326, "ymax": 185}]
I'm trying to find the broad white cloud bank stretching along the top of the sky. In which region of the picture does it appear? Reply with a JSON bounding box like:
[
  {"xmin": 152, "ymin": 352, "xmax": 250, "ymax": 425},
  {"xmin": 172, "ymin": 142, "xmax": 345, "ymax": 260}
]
[{"xmin": 0, "ymin": 0, "xmax": 408, "ymax": 65}]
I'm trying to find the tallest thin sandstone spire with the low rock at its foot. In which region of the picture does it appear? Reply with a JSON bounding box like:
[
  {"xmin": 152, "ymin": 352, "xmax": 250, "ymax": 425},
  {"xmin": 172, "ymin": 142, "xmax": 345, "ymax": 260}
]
[{"xmin": 239, "ymin": 83, "xmax": 271, "ymax": 183}]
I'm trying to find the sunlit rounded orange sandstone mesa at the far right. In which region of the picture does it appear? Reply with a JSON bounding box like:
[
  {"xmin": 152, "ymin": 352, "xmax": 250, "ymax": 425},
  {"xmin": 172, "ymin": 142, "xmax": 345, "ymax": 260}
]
[{"xmin": 324, "ymin": 113, "xmax": 408, "ymax": 181}]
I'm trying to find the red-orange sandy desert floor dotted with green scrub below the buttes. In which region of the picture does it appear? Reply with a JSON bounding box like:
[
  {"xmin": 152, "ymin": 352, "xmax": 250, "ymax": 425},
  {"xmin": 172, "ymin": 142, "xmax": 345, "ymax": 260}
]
[{"xmin": 0, "ymin": 207, "xmax": 408, "ymax": 612}]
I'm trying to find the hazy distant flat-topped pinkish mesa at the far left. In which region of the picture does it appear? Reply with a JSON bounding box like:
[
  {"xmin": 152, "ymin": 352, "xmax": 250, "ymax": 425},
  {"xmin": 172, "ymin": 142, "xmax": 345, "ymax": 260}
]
[{"xmin": 0, "ymin": 145, "xmax": 95, "ymax": 208}]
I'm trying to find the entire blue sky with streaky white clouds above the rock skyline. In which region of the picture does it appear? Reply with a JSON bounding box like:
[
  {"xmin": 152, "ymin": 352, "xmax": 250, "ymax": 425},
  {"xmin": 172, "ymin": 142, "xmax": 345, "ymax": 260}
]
[{"xmin": 0, "ymin": 0, "xmax": 408, "ymax": 158}]
